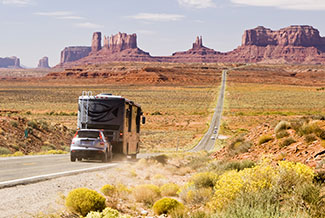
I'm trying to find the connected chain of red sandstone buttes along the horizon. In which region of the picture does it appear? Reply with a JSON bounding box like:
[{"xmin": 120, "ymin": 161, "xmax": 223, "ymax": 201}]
[{"xmin": 58, "ymin": 25, "xmax": 325, "ymax": 67}]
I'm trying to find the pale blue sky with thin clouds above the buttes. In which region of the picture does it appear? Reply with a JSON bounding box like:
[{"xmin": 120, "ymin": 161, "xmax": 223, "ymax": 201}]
[{"xmin": 0, "ymin": 0, "xmax": 325, "ymax": 67}]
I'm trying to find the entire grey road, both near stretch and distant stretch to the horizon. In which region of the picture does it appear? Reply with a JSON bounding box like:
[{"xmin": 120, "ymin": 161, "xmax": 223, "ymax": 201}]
[{"xmin": 0, "ymin": 70, "xmax": 227, "ymax": 188}]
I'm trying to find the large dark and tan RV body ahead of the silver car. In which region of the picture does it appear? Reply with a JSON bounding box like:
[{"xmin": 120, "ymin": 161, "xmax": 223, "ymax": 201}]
[{"xmin": 77, "ymin": 92, "xmax": 143, "ymax": 158}]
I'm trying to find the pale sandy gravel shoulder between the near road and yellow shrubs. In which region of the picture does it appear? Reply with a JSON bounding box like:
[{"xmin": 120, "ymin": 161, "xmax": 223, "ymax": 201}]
[{"xmin": 0, "ymin": 157, "xmax": 192, "ymax": 218}]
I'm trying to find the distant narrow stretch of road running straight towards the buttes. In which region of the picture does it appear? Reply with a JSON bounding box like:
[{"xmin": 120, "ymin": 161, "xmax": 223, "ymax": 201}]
[{"xmin": 190, "ymin": 70, "xmax": 228, "ymax": 152}]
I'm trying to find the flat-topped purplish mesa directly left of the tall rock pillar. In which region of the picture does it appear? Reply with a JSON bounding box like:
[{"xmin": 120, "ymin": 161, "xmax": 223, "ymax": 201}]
[{"xmin": 60, "ymin": 46, "xmax": 91, "ymax": 64}]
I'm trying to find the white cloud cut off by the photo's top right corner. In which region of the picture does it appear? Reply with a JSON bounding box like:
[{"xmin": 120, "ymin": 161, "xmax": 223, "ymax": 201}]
[{"xmin": 231, "ymin": 0, "xmax": 325, "ymax": 10}]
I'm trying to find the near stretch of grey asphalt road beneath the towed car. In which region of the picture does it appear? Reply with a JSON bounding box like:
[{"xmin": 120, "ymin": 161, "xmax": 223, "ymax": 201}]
[{"xmin": 0, "ymin": 155, "xmax": 117, "ymax": 188}]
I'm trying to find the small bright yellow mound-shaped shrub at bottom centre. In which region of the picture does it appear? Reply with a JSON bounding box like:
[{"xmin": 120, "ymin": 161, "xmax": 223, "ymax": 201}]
[{"xmin": 153, "ymin": 198, "xmax": 184, "ymax": 215}]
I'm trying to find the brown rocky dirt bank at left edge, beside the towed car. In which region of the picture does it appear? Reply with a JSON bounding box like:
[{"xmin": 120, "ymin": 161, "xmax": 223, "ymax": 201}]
[{"xmin": 0, "ymin": 114, "xmax": 73, "ymax": 154}]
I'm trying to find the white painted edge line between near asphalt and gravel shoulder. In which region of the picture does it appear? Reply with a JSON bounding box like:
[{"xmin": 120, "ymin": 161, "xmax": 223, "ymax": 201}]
[{"xmin": 0, "ymin": 163, "xmax": 118, "ymax": 189}]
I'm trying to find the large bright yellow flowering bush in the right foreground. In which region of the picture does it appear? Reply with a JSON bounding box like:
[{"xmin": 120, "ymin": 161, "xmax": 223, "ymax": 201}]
[{"xmin": 209, "ymin": 159, "xmax": 315, "ymax": 211}]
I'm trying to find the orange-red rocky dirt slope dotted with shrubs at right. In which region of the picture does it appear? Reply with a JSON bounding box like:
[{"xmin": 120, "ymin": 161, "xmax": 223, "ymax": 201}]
[{"xmin": 214, "ymin": 118, "xmax": 325, "ymax": 171}]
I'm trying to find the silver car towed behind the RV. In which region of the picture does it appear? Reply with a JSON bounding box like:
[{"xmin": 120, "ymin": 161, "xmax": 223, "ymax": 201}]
[{"xmin": 70, "ymin": 129, "xmax": 113, "ymax": 162}]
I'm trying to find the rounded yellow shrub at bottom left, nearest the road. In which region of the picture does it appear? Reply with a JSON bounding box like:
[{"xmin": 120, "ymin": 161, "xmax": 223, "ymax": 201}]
[{"xmin": 65, "ymin": 188, "xmax": 106, "ymax": 216}]
